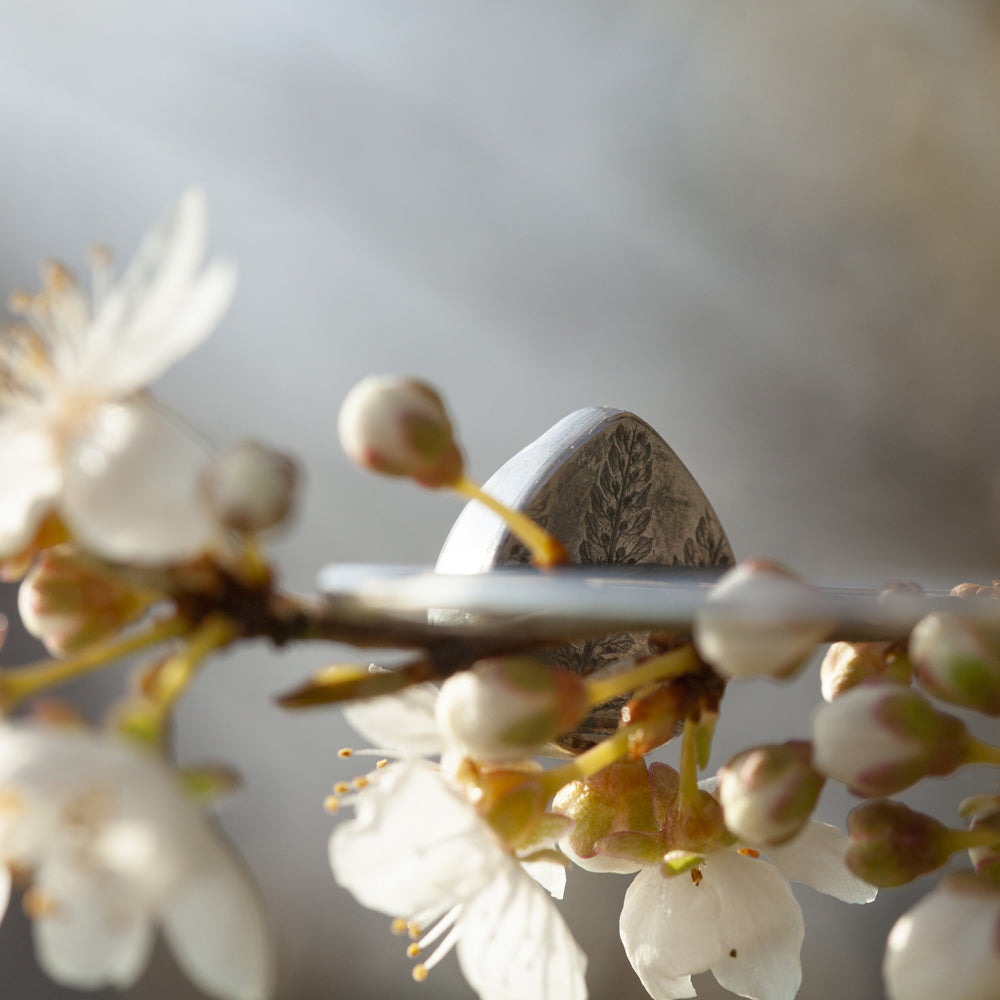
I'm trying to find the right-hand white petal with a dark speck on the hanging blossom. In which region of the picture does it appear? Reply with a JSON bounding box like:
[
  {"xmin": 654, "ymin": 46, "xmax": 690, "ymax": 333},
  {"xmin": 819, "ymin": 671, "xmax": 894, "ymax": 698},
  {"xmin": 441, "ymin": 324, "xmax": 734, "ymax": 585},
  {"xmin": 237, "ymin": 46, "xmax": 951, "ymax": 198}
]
[{"xmin": 698, "ymin": 851, "xmax": 805, "ymax": 1000}]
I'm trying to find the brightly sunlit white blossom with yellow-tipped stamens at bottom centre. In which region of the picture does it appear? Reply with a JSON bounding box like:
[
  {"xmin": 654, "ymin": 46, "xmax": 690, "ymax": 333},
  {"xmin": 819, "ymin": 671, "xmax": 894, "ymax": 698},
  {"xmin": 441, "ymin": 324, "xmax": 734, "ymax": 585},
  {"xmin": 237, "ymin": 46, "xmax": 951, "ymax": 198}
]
[{"xmin": 330, "ymin": 759, "xmax": 587, "ymax": 1000}]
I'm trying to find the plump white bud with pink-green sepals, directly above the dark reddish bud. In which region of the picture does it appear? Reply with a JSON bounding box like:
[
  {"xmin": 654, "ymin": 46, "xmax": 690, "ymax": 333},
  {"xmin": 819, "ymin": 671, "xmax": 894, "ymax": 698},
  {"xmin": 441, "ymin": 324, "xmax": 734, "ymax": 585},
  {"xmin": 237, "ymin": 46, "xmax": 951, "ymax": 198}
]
[{"xmin": 813, "ymin": 682, "xmax": 971, "ymax": 798}]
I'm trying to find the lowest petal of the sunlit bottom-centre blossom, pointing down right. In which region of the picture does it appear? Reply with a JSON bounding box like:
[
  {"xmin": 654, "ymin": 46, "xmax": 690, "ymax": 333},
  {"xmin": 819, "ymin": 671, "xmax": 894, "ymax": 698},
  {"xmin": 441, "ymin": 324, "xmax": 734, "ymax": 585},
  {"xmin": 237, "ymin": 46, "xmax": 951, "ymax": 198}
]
[{"xmin": 458, "ymin": 858, "xmax": 587, "ymax": 1000}]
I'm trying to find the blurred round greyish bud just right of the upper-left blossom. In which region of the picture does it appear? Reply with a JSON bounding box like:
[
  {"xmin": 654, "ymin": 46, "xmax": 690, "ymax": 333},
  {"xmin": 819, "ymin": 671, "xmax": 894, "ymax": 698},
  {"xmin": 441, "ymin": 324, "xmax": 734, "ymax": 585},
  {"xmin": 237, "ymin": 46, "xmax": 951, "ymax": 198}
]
[{"xmin": 202, "ymin": 441, "xmax": 297, "ymax": 534}]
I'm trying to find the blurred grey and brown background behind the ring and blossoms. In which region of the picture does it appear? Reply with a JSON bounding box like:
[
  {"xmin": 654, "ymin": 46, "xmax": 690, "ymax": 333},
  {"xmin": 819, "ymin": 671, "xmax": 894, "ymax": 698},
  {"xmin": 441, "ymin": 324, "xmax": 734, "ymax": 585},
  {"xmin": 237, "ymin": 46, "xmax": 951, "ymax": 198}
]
[{"xmin": 0, "ymin": 0, "xmax": 1000, "ymax": 1000}]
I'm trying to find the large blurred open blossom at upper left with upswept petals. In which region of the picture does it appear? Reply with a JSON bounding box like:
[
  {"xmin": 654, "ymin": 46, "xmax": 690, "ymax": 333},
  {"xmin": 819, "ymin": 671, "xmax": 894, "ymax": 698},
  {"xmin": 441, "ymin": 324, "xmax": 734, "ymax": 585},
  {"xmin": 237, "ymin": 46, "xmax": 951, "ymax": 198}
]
[{"xmin": 0, "ymin": 190, "xmax": 235, "ymax": 563}]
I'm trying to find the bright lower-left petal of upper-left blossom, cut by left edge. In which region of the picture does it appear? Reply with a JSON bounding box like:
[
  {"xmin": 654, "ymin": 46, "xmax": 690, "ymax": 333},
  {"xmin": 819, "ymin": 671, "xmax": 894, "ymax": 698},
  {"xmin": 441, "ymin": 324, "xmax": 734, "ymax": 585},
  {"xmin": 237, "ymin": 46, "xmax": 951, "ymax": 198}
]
[{"xmin": 0, "ymin": 418, "xmax": 62, "ymax": 558}]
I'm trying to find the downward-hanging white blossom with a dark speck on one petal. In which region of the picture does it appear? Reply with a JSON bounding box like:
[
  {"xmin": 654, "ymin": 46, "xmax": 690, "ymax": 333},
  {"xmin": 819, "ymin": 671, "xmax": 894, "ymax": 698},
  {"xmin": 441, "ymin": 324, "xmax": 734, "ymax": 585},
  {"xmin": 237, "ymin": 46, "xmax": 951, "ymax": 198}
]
[{"xmin": 619, "ymin": 822, "xmax": 875, "ymax": 1000}]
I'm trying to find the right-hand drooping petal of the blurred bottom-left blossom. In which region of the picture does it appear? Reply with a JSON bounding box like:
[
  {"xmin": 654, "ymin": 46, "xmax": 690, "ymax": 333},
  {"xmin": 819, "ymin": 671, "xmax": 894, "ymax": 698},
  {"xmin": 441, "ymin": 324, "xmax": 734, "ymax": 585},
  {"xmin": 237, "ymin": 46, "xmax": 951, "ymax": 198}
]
[{"xmin": 161, "ymin": 850, "xmax": 273, "ymax": 1000}]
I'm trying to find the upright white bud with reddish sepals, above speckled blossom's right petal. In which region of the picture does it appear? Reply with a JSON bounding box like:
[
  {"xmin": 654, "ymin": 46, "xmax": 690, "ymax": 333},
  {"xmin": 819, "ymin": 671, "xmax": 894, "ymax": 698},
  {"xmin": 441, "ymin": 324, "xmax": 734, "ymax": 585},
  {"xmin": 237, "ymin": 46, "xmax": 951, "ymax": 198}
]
[{"xmin": 716, "ymin": 740, "xmax": 826, "ymax": 847}]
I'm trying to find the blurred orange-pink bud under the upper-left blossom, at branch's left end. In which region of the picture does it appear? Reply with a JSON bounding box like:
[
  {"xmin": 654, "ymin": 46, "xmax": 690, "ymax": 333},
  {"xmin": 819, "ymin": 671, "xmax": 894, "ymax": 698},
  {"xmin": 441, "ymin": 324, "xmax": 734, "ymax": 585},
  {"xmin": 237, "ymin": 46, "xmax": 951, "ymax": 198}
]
[{"xmin": 17, "ymin": 545, "xmax": 158, "ymax": 656}]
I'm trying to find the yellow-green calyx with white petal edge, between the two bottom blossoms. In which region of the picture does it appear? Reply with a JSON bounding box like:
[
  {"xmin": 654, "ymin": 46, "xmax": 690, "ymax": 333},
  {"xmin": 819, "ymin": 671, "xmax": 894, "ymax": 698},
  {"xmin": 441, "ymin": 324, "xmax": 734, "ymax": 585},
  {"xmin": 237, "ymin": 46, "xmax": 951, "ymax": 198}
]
[{"xmin": 552, "ymin": 757, "xmax": 657, "ymax": 873}]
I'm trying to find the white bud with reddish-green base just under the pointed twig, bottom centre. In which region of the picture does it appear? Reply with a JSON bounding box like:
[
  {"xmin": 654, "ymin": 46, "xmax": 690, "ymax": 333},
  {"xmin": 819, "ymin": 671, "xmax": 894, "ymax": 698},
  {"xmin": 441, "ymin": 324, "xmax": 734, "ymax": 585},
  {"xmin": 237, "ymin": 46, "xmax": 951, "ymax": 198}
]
[{"xmin": 435, "ymin": 656, "xmax": 588, "ymax": 761}]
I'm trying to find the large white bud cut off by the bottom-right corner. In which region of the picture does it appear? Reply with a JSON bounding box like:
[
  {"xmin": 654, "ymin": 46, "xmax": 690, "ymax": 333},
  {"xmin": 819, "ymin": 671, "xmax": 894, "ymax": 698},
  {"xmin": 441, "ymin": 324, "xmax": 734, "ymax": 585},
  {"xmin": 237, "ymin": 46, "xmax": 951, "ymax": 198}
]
[{"xmin": 882, "ymin": 872, "xmax": 1000, "ymax": 1000}]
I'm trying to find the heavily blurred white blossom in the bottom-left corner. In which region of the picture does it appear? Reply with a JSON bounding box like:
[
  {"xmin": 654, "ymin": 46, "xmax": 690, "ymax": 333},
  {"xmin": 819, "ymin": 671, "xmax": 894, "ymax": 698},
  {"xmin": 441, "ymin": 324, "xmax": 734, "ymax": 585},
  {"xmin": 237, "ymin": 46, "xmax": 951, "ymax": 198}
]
[{"xmin": 0, "ymin": 724, "xmax": 272, "ymax": 1000}]
